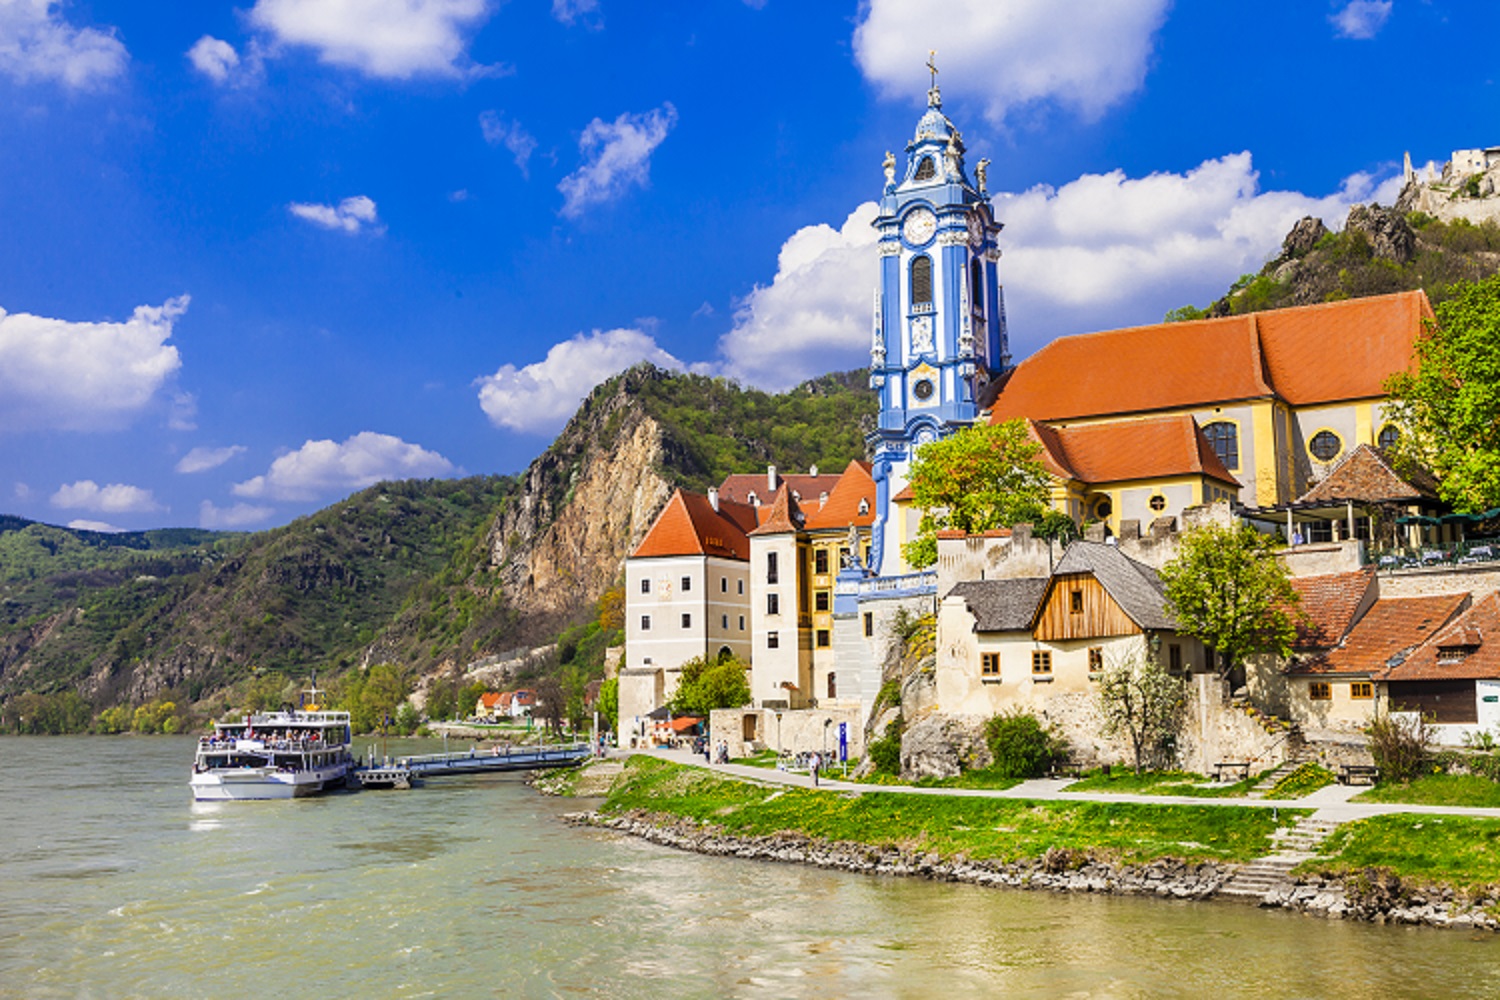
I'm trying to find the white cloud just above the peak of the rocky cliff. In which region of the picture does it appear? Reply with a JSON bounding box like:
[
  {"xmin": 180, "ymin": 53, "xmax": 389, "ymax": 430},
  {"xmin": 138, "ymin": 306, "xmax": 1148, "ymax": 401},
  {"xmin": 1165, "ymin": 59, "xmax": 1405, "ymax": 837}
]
[{"xmin": 476, "ymin": 330, "xmax": 683, "ymax": 433}]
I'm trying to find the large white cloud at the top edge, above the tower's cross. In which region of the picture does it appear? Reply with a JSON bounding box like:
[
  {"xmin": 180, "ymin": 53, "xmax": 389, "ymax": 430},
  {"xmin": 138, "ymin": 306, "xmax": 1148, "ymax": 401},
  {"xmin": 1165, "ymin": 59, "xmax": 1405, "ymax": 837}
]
[{"xmin": 854, "ymin": 0, "xmax": 1170, "ymax": 121}]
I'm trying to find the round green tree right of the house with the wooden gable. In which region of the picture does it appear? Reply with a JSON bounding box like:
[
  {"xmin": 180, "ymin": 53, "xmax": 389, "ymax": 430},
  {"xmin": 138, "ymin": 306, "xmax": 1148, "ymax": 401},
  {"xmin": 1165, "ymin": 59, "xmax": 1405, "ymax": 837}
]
[{"xmin": 1161, "ymin": 525, "xmax": 1298, "ymax": 676}]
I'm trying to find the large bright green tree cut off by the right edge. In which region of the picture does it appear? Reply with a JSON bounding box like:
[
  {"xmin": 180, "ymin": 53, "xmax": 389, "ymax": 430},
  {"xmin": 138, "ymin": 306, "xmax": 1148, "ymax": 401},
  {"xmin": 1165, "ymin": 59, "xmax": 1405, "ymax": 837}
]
[{"xmin": 1386, "ymin": 274, "xmax": 1500, "ymax": 513}]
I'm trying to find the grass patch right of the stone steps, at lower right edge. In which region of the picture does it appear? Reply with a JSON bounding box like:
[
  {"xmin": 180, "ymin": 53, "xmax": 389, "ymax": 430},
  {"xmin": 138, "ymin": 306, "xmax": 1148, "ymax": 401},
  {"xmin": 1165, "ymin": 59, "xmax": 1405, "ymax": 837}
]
[{"xmin": 1301, "ymin": 814, "xmax": 1500, "ymax": 886}]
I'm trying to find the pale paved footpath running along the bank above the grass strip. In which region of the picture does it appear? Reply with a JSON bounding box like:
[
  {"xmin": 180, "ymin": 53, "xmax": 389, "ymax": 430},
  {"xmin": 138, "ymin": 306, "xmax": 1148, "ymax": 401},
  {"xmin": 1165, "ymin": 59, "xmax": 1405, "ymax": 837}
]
[{"xmin": 636, "ymin": 750, "xmax": 1500, "ymax": 823}]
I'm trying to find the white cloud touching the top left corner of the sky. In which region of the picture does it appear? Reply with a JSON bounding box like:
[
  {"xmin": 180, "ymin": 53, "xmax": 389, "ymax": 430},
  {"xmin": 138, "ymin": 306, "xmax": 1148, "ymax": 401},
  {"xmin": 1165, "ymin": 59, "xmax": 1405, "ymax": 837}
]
[{"xmin": 0, "ymin": 0, "xmax": 131, "ymax": 90}]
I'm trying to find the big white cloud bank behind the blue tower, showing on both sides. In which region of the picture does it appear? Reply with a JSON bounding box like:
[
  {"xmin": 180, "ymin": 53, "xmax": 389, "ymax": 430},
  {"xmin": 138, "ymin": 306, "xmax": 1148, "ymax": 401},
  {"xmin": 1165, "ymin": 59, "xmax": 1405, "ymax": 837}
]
[{"xmin": 719, "ymin": 153, "xmax": 1401, "ymax": 390}]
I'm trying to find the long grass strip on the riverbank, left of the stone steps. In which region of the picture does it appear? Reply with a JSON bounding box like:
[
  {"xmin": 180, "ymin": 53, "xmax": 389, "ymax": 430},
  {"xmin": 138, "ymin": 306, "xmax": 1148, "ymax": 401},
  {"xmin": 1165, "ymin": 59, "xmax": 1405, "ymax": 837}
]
[{"xmin": 603, "ymin": 756, "xmax": 1301, "ymax": 862}]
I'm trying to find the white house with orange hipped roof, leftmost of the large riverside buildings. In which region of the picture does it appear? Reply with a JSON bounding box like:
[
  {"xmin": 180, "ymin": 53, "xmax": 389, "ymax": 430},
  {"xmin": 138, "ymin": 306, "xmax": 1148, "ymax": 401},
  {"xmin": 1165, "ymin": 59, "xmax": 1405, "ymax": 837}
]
[{"xmin": 620, "ymin": 489, "xmax": 758, "ymax": 745}]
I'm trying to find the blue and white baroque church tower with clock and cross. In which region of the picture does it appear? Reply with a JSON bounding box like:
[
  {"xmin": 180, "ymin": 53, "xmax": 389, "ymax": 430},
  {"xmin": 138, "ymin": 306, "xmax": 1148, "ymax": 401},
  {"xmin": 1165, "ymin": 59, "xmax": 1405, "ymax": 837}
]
[{"xmin": 869, "ymin": 74, "xmax": 1011, "ymax": 576}]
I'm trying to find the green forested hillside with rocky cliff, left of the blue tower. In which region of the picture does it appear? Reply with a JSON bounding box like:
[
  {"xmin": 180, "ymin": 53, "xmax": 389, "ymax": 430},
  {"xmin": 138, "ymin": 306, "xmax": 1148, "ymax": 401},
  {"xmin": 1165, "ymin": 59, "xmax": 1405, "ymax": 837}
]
[{"xmin": 0, "ymin": 366, "xmax": 876, "ymax": 729}]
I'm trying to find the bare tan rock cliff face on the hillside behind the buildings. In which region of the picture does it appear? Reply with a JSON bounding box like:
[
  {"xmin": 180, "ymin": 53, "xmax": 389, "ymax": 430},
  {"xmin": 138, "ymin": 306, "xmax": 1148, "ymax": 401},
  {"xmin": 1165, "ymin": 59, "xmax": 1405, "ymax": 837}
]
[{"xmin": 489, "ymin": 366, "xmax": 672, "ymax": 629}]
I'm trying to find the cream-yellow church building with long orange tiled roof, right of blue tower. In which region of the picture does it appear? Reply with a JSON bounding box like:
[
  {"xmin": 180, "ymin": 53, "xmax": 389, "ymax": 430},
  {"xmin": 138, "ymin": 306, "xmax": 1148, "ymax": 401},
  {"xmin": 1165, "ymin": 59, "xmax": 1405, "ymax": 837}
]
[{"xmin": 989, "ymin": 291, "xmax": 1433, "ymax": 532}]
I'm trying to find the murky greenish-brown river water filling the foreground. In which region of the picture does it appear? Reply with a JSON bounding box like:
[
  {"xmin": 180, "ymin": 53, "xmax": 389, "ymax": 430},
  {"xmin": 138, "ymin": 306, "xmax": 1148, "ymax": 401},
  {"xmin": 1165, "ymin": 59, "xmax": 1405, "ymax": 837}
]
[{"xmin": 0, "ymin": 736, "xmax": 1500, "ymax": 1000}]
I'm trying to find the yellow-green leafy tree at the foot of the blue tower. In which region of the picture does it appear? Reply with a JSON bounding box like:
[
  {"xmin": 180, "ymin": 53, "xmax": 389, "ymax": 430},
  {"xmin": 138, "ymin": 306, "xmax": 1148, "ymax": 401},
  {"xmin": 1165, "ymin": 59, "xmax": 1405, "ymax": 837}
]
[{"xmin": 902, "ymin": 420, "xmax": 1052, "ymax": 567}]
